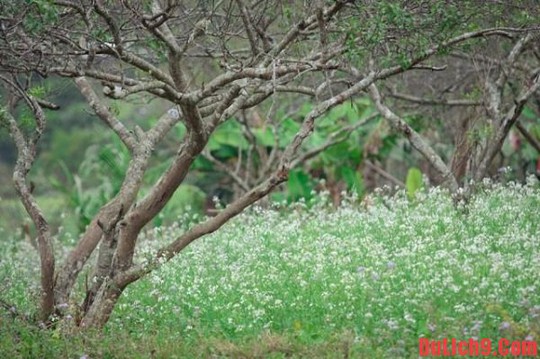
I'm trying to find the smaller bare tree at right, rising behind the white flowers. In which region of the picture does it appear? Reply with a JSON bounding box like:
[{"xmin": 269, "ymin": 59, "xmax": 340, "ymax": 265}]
[{"xmin": 370, "ymin": 29, "xmax": 540, "ymax": 191}]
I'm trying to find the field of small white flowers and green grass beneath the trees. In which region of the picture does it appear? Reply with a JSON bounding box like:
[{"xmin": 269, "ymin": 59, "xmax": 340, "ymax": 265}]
[{"xmin": 0, "ymin": 184, "xmax": 540, "ymax": 358}]
